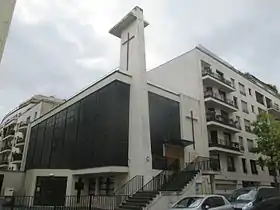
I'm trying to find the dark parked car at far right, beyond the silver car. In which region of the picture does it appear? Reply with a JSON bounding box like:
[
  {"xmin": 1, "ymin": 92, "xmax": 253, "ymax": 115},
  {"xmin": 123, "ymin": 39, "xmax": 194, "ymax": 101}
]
[{"xmin": 229, "ymin": 187, "xmax": 279, "ymax": 210}]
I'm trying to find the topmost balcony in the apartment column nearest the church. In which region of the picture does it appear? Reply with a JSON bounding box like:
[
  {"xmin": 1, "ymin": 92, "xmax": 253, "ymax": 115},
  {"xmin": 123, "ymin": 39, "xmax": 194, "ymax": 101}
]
[{"xmin": 202, "ymin": 68, "xmax": 235, "ymax": 92}]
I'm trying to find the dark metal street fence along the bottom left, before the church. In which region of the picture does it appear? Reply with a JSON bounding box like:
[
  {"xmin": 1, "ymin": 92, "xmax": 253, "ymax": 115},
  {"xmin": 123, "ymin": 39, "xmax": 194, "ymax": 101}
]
[{"xmin": 1, "ymin": 195, "xmax": 125, "ymax": 210}]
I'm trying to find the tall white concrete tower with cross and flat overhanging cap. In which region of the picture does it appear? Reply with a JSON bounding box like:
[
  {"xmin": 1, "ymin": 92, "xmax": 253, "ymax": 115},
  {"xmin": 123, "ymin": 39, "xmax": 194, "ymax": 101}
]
[{"xmin": 110, "ymin": 7, "xmax": 152, "ymax": 179}]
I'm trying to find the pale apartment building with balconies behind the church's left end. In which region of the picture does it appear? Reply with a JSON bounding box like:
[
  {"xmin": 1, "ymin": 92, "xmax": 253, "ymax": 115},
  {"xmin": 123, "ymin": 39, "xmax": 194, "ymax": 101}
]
[{"xmin": 0, "ymin": 95, "xmax": 63, "ymax": 171}]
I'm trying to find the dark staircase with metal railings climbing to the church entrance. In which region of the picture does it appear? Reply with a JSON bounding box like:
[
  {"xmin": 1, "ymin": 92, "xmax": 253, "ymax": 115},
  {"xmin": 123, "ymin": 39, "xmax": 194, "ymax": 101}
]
[{"xmin": 115, "ymin": 157, "xmax": 219, "ymax": 210}]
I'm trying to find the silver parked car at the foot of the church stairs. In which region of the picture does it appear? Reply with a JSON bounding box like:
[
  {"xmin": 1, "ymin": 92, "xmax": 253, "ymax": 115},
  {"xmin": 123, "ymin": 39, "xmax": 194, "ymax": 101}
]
[{"xmin": 171, "ymin": 195, "xmax": 233, "ymax": 210}]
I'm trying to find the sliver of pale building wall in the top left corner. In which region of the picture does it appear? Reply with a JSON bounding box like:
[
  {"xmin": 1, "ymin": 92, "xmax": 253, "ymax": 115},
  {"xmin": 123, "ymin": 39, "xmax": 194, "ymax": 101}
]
[{"xmin": 0, "ymin": 0, "xmax": 16, "ymax": 63}]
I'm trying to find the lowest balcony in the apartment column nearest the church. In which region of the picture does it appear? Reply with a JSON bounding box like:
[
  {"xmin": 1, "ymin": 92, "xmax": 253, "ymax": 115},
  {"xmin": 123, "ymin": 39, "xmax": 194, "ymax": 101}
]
[{"xmin": 209, "ymin": 139, "xmax": 242, "ymax": 155}]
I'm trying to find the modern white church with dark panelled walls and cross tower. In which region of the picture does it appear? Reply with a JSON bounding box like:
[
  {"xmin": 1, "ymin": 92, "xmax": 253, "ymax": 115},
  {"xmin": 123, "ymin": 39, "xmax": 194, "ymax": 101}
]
[{"xmin": 18, "ymin": 7, "xmax": 225, "ymax": 208}]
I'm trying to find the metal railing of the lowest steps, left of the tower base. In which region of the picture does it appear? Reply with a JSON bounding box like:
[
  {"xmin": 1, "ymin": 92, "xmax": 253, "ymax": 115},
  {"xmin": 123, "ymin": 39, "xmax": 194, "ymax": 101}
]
[{"xmin": 114, "ymin": 175, "xmax": 144, "ymax": 206}]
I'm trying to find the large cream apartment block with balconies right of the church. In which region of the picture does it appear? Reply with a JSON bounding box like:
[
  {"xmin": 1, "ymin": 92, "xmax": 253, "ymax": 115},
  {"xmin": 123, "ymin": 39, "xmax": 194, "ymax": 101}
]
[{"xmin": 148, "ymin": 46, "xmax": 280, "ymax": 194}]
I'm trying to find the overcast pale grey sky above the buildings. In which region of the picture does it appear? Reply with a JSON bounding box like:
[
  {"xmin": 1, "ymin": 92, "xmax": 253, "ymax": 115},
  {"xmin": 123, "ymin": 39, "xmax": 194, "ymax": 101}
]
[{"xmin": 0, "ymin": 0, "xmax": 280, "ymax": 118}]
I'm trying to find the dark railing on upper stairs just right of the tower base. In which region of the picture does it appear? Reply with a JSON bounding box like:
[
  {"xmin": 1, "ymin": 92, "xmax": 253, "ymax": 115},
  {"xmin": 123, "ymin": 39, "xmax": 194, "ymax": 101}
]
[{"xmin": 139, "ymin": 160, "xmax": 179, "ymax": 192}]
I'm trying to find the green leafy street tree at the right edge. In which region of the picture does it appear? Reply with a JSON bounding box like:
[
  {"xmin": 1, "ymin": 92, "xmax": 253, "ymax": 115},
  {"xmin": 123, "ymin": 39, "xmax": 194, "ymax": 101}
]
[{"xmin": 252, "ymin": 113, "xmax": 280, "ymax": 189}]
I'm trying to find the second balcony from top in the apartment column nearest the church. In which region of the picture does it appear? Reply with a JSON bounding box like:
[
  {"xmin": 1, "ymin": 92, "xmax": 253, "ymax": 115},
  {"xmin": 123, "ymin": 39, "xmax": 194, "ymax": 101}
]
[{"xmin": 204, "ymin": 91, "xmax": 238, "ymax": 112}]
